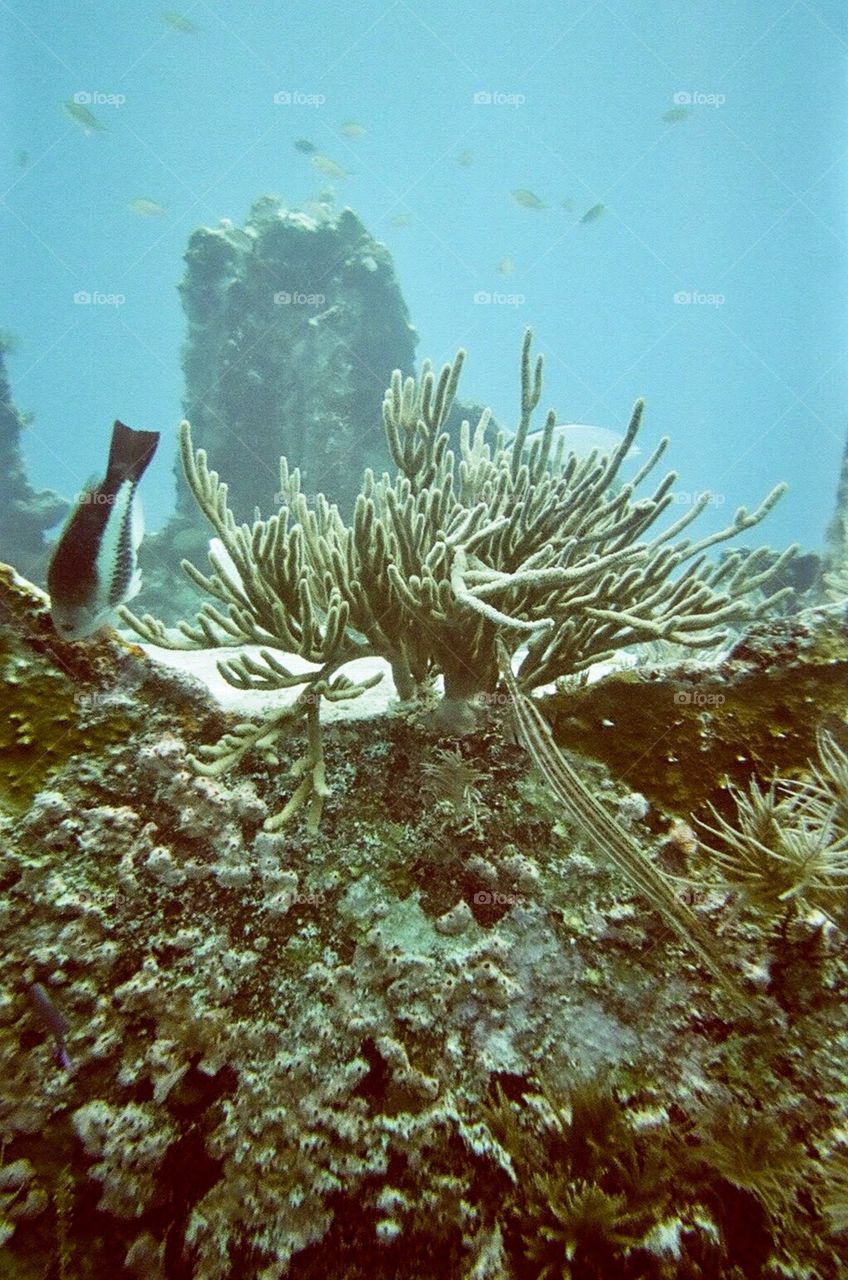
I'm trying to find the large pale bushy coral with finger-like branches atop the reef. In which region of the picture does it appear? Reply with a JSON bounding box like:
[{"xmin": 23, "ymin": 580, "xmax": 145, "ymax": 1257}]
[{"xmin": 122, "ymin": 332, "xmax": 794, "ymax": 828}]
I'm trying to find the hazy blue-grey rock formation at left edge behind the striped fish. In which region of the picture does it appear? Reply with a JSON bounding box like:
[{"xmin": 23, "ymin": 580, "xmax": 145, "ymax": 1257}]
[{"xmin": 0, "ymin": 342, "xmax": 68, "ymax": 582}]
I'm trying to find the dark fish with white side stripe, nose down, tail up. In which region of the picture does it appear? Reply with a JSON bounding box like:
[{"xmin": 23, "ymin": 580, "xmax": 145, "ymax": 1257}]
[{"xmin": 47, "ymin": 422, "xmax": 159, "ymax": 640}]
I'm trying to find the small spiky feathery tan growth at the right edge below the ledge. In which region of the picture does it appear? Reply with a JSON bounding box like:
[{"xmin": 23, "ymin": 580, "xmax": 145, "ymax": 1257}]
[{"xmin": 703, "ymin": 733, "xmax": 848, "ymax": 916}]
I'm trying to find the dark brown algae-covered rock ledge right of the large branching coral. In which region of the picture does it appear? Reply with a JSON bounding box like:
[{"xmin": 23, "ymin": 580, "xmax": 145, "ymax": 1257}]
[{"xmin": 546, "ymin": 607, "xmax": 848, "ymax": 815}]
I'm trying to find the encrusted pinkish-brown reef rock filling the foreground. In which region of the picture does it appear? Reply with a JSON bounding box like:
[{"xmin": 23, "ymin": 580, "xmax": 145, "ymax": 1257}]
[{"xmin": 0, "ymin": 576, "xmax": 848, "ymax": 1280}]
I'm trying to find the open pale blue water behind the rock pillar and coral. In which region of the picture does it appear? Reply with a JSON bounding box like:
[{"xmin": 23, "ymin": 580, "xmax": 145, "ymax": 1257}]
[{"xmin": 0, "ymin": 0, "xmax": 848, "ymax": 547}]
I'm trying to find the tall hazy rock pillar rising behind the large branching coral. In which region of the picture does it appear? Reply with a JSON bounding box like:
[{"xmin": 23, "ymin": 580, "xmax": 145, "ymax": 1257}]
[{"xmin": 177, "ymin": 197, "xmax": 416, "ymax": 521}]
